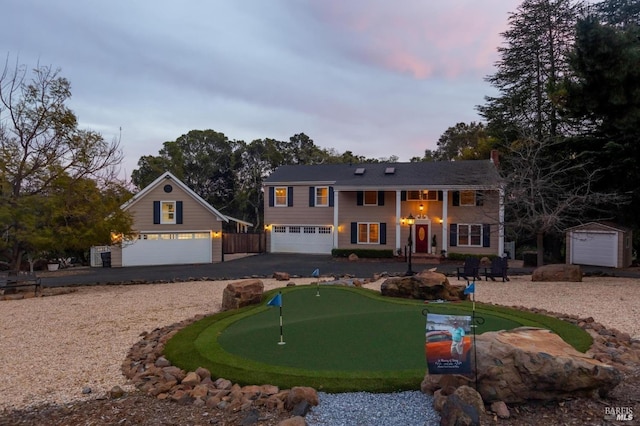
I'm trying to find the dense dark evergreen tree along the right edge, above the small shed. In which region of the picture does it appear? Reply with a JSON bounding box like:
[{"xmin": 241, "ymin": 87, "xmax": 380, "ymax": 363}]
[{"xmin": 559, "ymin": 5, "xmax": 640, "ymax": 235}]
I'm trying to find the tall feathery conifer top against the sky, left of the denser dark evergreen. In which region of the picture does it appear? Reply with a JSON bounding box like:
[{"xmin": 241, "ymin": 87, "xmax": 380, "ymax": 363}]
[{"xmin": 478, "ymin": 0, "xmax": 580, "ymax": 140}]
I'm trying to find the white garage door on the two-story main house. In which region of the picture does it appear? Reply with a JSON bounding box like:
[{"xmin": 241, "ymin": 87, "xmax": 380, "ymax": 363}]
[{"xmin": 271, "ymin": 225, "xmax": 333, "ymax": 254}]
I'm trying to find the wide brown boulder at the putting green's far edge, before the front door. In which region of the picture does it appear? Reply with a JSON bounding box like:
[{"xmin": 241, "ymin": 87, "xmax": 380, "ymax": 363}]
[{"xmin": 380, "ymin": 270, "xmax": 467, "ymax": 301}]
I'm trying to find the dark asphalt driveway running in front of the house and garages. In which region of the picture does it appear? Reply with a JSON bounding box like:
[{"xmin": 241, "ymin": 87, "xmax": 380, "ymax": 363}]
[{"xmin": 42, "ymin": 253, "xmax": 640, "ymax": 287}]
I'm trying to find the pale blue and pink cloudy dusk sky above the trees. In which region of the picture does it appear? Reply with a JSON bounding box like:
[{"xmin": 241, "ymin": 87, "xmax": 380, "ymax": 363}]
[{"xmin": 0, "ymin": 0, "xmax": 521, "ymax": 177}]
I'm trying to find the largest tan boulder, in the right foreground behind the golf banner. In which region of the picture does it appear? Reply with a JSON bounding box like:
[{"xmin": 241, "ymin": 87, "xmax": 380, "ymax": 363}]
[{"xmin": 421, "ymin": 327, "xmax": 622, "ymax": 404}]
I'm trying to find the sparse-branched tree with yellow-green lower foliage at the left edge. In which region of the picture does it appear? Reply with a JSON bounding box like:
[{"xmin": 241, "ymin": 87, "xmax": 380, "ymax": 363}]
[{"xmin": 0, "ymin": 60, "xmax": 130, "ymax": 269}]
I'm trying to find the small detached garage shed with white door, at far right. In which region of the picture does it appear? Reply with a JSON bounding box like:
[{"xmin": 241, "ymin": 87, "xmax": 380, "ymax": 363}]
[{"xmin": 566, "ymin": 222, "xmax": 632, "ymax": 268}]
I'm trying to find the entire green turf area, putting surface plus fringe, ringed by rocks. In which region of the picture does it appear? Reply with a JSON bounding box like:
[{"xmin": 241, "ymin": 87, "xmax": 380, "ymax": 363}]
[{"xmin": 165, "ymin": 286, "xmax": 591, "ymax": 392}]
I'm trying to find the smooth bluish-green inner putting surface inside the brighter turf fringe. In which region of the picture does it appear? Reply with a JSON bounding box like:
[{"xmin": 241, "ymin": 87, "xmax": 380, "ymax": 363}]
[{"xmin": 218, "ymin": 286, "xmax": 520, "ymax": 371}]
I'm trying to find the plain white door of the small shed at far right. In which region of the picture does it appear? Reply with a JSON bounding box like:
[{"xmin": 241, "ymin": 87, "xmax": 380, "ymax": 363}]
[{"xmin": 571, "ymin": 231, "xmax": 618, "ymax": 267}]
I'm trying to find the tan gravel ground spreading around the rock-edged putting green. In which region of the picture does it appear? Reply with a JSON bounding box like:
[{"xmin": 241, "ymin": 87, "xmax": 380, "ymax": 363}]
[{"xmin": 0, "ymin": 276, "xmax": 640, "ymax": 418}]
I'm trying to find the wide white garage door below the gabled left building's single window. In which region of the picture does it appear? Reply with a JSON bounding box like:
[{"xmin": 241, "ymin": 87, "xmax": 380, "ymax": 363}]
[{"xmin": 122, "ymin": 231, "xmax": 211, "ymax": 266}]
